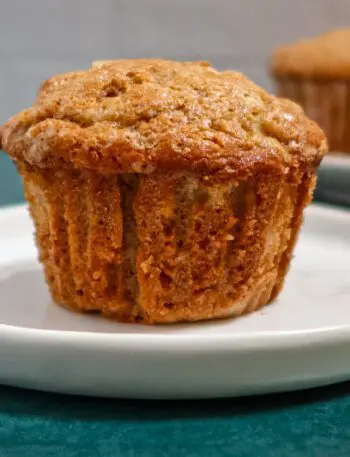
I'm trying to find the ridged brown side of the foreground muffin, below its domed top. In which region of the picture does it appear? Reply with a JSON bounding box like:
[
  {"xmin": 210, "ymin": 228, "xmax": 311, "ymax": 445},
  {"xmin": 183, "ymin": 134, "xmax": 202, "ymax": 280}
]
[{"xmin": 19, "ymin": 159, "xmax": 315, "ymax": 323}]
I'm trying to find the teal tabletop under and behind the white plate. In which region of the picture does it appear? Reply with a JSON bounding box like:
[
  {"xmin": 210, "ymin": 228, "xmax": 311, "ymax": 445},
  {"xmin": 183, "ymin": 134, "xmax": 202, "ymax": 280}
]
[{"xmin": 0, "ymin": 155, "xmax": 350, "ymax": 457}]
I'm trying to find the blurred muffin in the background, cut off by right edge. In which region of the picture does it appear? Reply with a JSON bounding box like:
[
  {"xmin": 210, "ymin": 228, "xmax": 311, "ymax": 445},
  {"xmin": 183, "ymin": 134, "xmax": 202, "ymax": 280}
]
[{"xmin": 272, "ymin": 29, "xmax": 350, "ymax": 153}]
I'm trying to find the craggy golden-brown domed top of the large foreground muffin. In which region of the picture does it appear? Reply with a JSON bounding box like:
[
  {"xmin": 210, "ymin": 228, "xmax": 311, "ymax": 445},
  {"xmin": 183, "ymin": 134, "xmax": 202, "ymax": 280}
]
[{"xmin": 2, "ymin": 59, "xmax": 326, "ymax": 176}]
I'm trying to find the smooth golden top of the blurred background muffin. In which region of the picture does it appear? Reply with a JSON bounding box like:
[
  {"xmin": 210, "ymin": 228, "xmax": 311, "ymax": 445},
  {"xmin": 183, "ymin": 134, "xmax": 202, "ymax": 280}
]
[{"xmin": 272, "ymin": 29, "xmax": 350, "ymax": 80}]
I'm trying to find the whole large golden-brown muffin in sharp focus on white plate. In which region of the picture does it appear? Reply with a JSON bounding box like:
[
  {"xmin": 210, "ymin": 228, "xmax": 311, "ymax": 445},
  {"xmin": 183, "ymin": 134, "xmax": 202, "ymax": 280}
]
[{"xmin": 2, "ymin": 59, "xmax": 326, "ymax": 324}]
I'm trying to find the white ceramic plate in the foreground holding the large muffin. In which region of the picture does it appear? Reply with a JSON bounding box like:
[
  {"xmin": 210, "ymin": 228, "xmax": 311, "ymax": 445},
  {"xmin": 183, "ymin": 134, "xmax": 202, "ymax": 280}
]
[{"xmin": 0, "ymin": 206, "xmax": 350, "ymax": 398}]
